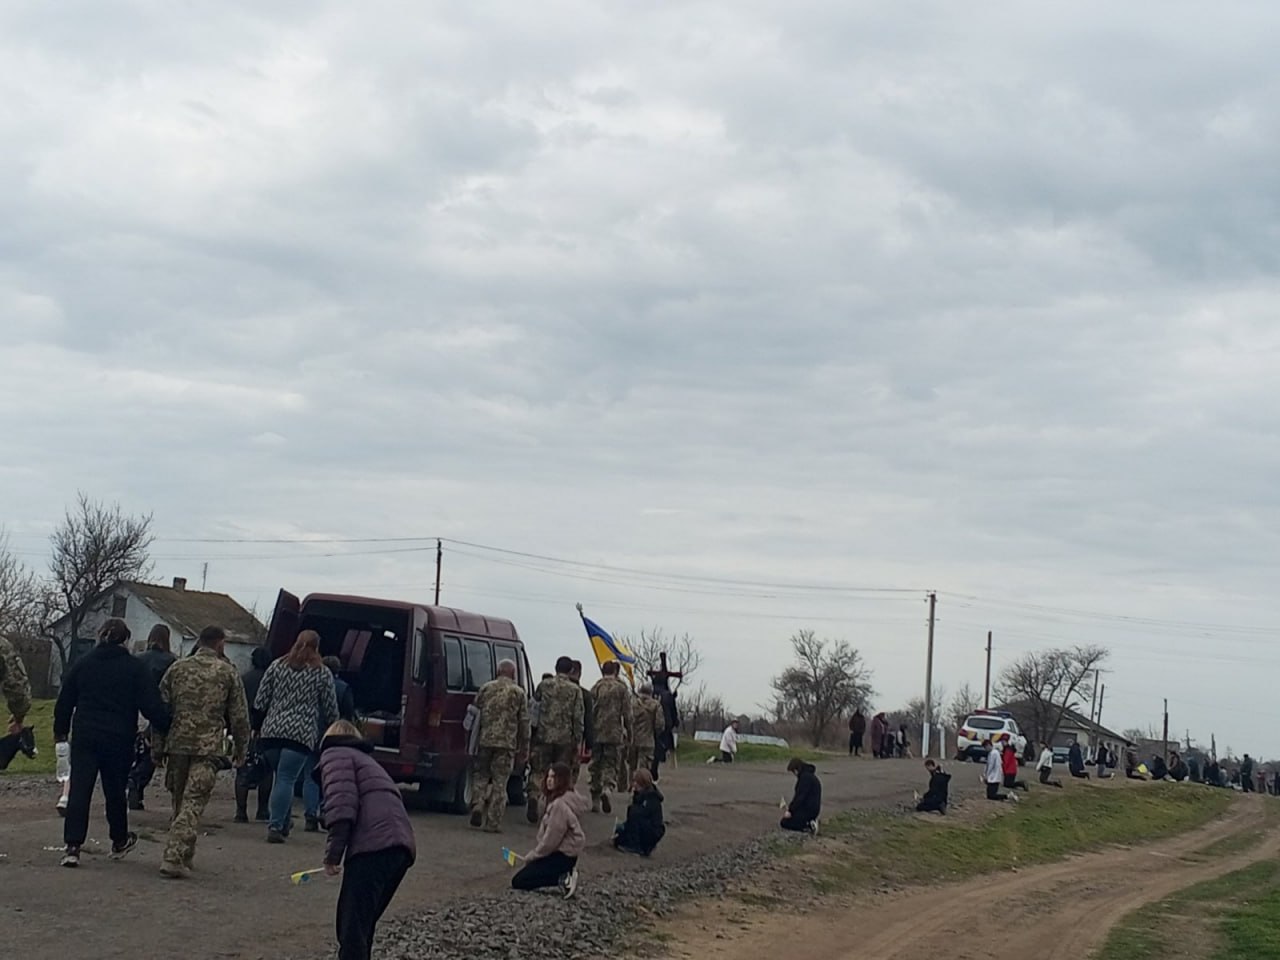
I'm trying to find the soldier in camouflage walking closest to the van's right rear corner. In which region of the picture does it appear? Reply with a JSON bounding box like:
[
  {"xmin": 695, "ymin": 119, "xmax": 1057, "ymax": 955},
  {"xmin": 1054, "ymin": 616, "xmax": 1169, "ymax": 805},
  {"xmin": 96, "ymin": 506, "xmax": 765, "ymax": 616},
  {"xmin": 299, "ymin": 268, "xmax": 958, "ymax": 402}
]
[{"xmin": 471, "ymin": 660, "xmax": 529, "ymax": 833}]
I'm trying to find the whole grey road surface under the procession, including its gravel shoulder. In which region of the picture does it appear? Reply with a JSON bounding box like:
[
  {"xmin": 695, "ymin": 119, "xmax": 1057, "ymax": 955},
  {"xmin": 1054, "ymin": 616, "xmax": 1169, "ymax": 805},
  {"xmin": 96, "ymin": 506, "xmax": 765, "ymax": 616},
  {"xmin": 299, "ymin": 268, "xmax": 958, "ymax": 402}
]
[{"xmin": 0, "ymin": 756, "xmax": 977, "ymax": 960}]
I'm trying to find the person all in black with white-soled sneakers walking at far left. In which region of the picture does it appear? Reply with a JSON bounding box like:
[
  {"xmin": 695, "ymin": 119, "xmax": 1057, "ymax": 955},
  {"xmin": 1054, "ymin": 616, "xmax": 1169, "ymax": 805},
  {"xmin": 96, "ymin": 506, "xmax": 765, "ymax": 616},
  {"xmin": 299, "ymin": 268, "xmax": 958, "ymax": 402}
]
[{"xmin": 54, "ymin": 618, "xmax": 169, "ymax": 867}]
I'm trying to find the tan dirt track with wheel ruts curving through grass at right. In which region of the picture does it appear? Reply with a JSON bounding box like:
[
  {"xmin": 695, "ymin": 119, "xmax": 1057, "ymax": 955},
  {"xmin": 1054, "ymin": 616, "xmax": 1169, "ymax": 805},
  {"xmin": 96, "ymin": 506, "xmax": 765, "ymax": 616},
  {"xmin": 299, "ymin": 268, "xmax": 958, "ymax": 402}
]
[{"xmin": 669, "ymin": 796, "xmax": 1280, "ymax": 960}]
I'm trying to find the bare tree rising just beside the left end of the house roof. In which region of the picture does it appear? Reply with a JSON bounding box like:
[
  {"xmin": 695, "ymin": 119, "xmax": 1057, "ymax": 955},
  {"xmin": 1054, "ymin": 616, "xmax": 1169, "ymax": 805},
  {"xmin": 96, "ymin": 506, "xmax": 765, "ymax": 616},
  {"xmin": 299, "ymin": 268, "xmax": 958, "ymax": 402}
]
[{"xmin": 46, "ymin": 493, "xmax": 155, "ymax": 669}]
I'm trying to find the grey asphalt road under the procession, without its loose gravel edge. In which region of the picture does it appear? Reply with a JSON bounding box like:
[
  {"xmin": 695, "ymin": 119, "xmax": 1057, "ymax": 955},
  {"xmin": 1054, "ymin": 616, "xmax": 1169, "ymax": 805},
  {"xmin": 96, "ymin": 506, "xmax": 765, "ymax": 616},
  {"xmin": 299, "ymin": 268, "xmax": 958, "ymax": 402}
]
[{"xmin": 0, "ymin": 758, "xmax": 942, "ymax": 960}]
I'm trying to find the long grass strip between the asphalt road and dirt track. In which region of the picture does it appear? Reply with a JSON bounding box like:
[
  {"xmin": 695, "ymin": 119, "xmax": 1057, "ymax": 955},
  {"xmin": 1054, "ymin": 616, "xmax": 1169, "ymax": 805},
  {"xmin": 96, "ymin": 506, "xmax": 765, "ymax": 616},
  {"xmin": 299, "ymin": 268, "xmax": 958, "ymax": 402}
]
[{"xmin": 813, "ymin": 785, "xmax": 1233, "ymax": 892}]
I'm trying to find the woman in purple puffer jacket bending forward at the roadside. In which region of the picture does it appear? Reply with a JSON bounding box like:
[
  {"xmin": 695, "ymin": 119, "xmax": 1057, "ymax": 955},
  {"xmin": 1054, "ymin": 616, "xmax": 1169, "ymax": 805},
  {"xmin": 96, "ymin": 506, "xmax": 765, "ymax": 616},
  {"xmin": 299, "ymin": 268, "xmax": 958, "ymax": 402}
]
[{"xmin": 312, "ymin": 721, "xmax": 417, "ymax": 960}]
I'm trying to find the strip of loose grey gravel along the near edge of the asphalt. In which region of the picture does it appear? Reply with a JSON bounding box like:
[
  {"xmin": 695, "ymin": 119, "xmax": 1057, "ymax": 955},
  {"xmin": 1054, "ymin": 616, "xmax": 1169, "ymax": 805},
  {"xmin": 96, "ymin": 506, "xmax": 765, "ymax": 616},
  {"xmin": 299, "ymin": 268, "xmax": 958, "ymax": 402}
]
[{"xmin": 376, "ymin": 836, "xmax": 800, "ymax": 960}]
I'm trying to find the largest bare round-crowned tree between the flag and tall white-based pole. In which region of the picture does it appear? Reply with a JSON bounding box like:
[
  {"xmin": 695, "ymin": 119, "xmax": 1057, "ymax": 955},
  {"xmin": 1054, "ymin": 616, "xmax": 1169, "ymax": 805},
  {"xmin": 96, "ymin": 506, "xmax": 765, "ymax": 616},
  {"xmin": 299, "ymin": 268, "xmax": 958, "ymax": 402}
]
[{"xmin": 773, "ymin": 630, "xmax": 874, "ymax": 746}]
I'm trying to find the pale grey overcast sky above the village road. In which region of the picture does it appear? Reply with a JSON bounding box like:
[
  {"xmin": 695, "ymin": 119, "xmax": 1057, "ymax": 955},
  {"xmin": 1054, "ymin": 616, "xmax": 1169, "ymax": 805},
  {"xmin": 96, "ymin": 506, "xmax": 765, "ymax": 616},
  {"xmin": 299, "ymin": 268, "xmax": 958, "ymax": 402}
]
[{"xmin": 0, "ymin": 0, "xmax": 1280, "ymax": 756}]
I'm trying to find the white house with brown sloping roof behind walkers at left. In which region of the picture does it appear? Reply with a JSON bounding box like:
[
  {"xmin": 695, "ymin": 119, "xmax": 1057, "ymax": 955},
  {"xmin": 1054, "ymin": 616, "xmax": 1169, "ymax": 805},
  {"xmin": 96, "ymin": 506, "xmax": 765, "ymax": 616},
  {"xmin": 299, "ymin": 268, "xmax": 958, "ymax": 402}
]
[{"xmin": 49, "ymin": 577, "xmax": 266, "ymax": 687}]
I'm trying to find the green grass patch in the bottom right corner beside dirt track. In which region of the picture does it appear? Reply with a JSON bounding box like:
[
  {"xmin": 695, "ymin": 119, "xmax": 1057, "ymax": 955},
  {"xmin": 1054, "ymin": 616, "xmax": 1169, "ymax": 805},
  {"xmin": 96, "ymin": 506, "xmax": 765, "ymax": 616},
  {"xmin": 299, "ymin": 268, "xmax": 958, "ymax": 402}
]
[{"xmin": 1096, "ymin": 860, "xmax": 1280, "ymax": 960}]
